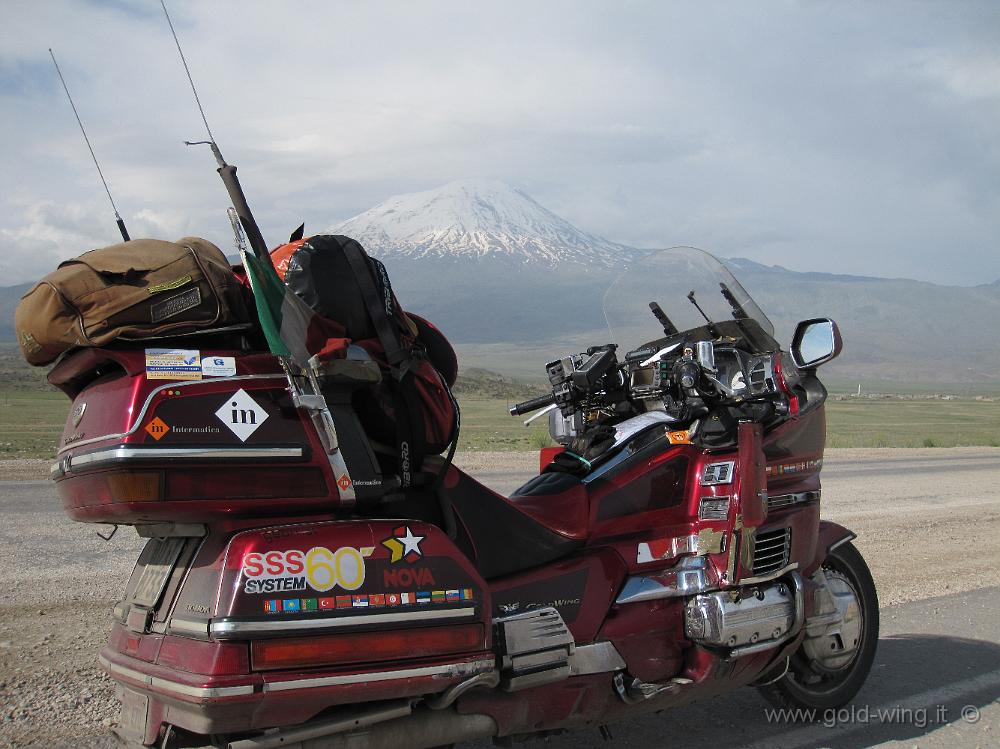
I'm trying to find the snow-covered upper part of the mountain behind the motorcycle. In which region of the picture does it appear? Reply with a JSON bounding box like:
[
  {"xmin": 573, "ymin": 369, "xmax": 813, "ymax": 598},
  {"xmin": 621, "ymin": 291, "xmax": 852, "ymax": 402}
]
[{"xmin": 330, "ymin": 180, "xmax": 635, "ymax": 268}]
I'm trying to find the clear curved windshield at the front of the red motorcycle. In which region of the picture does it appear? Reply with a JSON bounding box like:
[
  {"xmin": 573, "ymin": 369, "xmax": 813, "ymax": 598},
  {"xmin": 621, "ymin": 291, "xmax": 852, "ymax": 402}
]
[{"xmin": 604, "ymin": 247, "xmax": 780, "ymax": 356}]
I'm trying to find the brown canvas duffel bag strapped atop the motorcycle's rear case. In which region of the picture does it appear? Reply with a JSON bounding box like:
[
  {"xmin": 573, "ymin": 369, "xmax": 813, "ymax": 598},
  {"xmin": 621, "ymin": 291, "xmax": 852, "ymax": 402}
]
[{"xmin": 14, "ymin": 237, "xmax": 248, "ymax": 366}]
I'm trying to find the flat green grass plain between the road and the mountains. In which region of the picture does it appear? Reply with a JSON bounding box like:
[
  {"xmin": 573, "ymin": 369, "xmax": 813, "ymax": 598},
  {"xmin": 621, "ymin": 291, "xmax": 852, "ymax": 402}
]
[{"xmin": 0, "ymin": 386, "xmax": 1000, "ymax": 458}]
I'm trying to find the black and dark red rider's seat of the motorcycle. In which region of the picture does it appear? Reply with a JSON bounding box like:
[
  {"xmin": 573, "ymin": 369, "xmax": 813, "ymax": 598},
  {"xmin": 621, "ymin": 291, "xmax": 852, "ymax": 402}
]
[{"xmin": 439, "ymin": 466, "xmax": 588, "ymax": 580}]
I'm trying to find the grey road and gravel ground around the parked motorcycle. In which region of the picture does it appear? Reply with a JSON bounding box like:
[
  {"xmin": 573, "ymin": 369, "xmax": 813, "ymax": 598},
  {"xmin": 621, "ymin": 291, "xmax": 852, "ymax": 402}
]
[{"xmin": 0, "ymin": 448, "xmax": 1000, "ymax": 749}]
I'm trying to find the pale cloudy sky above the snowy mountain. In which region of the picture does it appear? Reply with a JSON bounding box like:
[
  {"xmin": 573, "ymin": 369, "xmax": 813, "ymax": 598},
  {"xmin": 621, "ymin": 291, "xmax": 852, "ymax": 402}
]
[{"xmin": 0, "ymin": 0, "xmax": 1000, "ymax": 285}]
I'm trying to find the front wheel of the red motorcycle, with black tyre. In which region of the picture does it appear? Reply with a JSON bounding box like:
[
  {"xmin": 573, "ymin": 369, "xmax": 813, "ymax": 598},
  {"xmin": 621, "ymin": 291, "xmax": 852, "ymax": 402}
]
[{"xmin": 759, "ymin": 543, "xmax": 878, "ymax": 718}]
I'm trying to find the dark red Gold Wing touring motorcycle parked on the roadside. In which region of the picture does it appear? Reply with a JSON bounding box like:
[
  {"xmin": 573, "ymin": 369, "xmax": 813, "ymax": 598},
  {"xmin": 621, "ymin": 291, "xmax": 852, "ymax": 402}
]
[{"xmin": 50, "ymin": 248, "xmax": 878, "ymax": 749}]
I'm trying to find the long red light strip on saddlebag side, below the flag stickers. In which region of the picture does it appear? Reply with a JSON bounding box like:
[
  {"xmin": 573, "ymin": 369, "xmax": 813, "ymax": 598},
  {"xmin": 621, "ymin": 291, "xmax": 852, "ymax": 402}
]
[{"xmin": 250, "ymin": 624, "xmax": 486, "ymax": 671}]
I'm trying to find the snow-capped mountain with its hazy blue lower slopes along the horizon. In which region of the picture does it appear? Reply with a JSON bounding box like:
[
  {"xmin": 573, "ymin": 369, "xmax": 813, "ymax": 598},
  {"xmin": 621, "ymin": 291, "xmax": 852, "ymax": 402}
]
[{"xmin": 0, "ymin": 180, "xmax": 1000, "ymax": 386}]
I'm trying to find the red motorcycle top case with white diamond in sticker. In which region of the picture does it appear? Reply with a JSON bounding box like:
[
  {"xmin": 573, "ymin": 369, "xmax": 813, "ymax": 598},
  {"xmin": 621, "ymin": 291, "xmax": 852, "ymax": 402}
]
[{"xmin": 49, "ymin": 347, "xmax": 360, "ymax": 525}]
